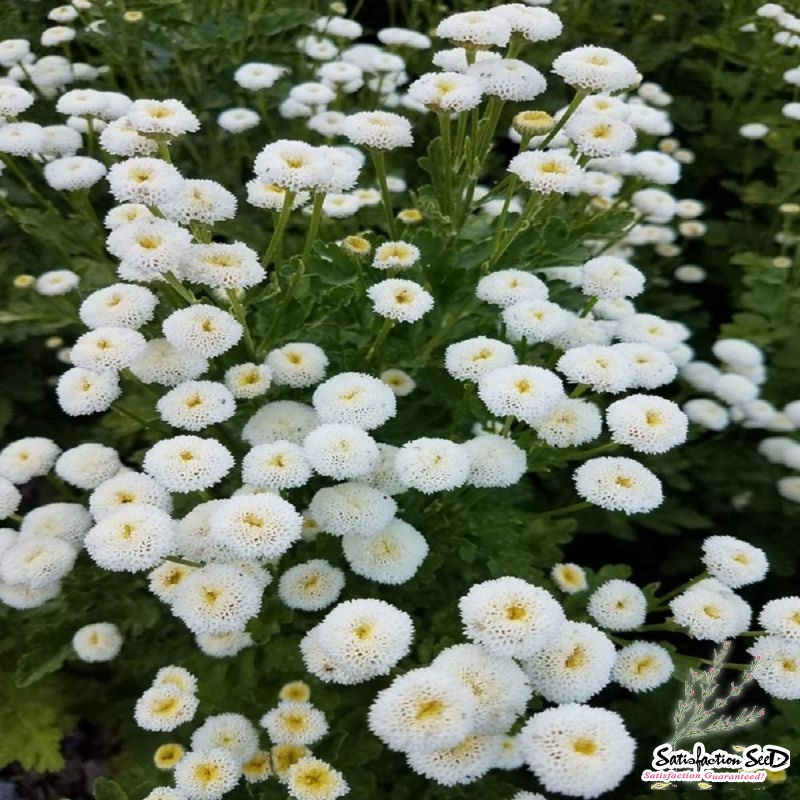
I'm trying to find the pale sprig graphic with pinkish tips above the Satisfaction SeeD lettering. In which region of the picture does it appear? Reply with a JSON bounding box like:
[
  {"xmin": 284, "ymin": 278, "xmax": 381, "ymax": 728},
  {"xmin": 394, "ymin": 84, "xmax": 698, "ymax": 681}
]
[{"xmin": 670, "ymin": 641, "xmax": 764, "ymax": 747}]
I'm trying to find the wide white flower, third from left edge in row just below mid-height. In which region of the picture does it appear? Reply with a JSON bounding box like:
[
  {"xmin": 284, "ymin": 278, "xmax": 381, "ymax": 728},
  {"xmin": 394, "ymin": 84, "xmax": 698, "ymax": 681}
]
[{"xmin": 142, "ymin": 436, "xmax": 234, "ymax": 493}]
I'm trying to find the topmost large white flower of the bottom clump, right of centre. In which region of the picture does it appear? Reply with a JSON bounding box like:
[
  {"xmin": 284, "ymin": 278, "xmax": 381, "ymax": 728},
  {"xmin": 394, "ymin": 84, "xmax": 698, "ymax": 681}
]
[{"xmin": 458, "ymin": 577, "xmax": 564, "ymax": 658}]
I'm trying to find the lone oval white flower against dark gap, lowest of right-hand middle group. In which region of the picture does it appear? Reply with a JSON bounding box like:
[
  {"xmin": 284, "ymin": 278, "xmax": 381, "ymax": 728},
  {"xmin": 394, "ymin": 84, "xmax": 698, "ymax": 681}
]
[{"xmin": 573, "ymin": 456, "xmax": 664, "ymax": 514}]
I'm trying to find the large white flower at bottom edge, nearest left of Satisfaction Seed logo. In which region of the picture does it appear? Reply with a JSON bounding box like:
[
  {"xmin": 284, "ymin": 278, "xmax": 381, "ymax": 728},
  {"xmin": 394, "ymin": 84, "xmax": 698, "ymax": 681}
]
[{"xmin": 519, "ymin": 703, "xmax": 636, "ymax": 800}]
